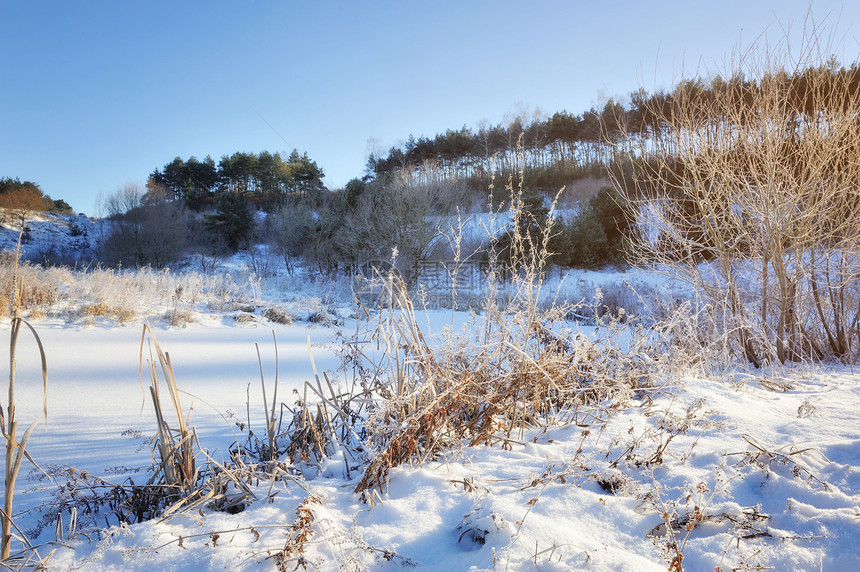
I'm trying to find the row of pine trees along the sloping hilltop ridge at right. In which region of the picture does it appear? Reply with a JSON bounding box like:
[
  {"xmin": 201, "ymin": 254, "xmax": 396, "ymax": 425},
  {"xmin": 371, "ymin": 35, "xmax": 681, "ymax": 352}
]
[{"xmin": 367, "ymin": 58, "xmax": 860, "ymax": 191}]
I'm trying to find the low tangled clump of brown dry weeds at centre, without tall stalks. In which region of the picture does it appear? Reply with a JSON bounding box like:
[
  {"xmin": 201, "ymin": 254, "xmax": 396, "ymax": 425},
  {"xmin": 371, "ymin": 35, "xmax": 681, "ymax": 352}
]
[{"xmin": 350, "ymin": 270, "xmax": 650, "ymax": 492}]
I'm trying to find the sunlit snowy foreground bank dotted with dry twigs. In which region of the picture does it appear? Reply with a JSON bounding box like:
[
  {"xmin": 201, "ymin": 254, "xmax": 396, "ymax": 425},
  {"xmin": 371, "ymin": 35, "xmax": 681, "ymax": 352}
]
[{"xmin": 31, "ymin": 336, "xmax": 860, "ymax": 571}]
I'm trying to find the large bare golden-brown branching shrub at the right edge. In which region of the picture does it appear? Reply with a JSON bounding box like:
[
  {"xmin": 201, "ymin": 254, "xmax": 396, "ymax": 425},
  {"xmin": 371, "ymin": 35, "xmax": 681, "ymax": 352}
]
[{"xmin": 615, "ymin": 19, "xmax": 860, "ymax": 366}]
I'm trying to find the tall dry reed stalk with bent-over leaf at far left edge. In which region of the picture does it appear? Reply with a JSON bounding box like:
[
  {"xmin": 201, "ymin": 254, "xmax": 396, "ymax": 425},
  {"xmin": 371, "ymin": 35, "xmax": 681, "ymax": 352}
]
[{"xmin": 0, "ymin": 217, "xmax": 48, "ymax": 560}]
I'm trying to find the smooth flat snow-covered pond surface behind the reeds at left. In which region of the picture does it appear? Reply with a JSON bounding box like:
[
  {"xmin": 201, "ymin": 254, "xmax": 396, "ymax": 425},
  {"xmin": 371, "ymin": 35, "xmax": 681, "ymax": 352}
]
[{"xmin": 10, "ymin": 317, "xmax": 337, "ymax": 560}]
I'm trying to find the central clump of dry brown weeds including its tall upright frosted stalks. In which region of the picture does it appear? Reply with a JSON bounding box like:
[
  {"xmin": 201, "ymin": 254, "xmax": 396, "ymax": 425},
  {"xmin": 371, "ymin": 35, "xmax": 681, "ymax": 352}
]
[{"xmin": 340, "ymin": 159, "xmax": 648, "ymax": 499}]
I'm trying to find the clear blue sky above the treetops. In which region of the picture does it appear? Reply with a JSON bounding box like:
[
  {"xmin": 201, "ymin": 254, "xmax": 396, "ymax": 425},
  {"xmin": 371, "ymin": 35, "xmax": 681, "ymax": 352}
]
[{"xmin": 0, "ymin": 0, "xmax": 860, "ymax": 213}]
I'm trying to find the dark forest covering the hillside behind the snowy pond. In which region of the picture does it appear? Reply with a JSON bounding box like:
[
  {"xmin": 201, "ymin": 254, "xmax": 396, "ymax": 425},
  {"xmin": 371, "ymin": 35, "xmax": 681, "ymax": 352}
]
[{"xmin": 6, "ymin": 59, "xmax": 860, "ymax": 286}]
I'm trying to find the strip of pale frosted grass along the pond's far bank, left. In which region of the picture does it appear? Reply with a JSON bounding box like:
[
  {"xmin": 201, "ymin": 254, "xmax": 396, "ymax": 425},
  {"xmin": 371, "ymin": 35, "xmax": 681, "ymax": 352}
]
[{"xmin": 0, "ymin": 257, "xmax": 351, "ymax": 326}]
